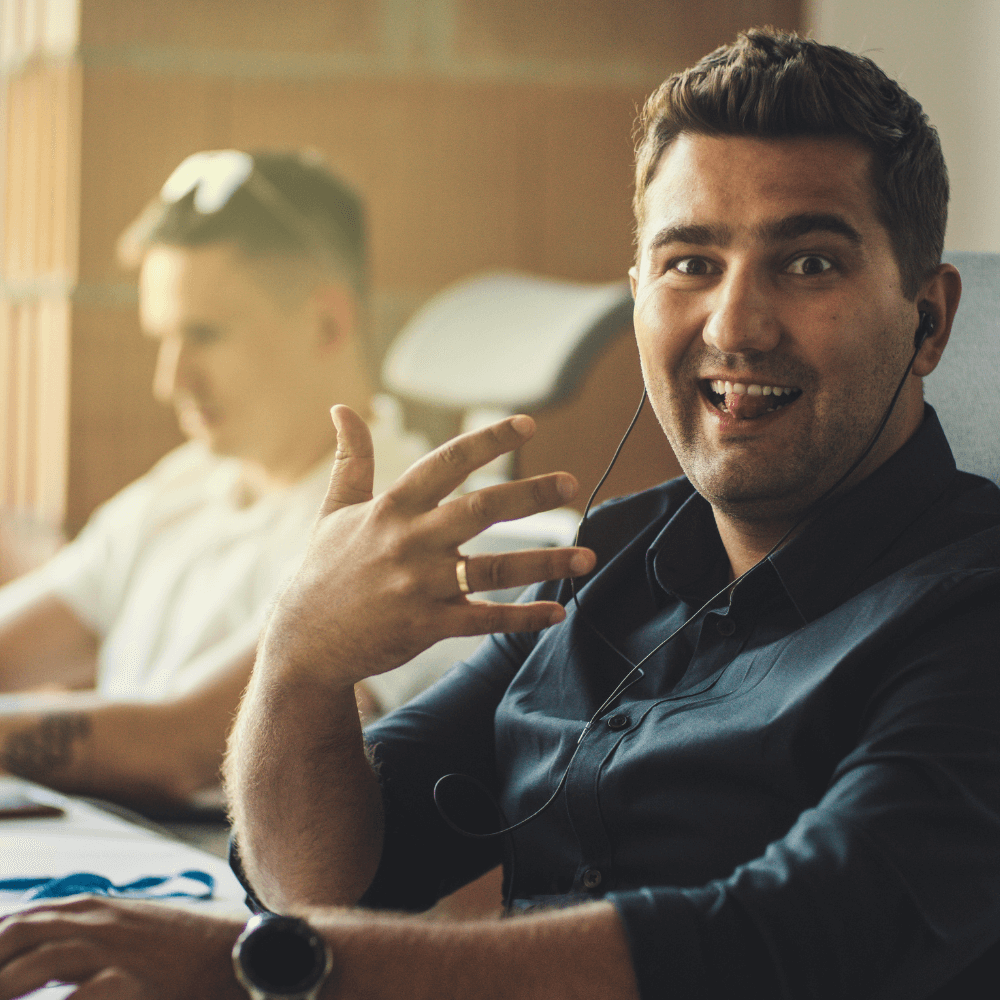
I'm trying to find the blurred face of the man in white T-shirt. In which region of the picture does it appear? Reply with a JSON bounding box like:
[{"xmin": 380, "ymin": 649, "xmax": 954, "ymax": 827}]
[{"xmin": 139, "ymin": 243, "xmax": 314, "ymax": 467}]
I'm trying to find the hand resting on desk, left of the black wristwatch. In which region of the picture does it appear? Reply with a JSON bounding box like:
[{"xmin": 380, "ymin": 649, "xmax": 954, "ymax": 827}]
[{"xmin": 0, "ymin": 896, "xmax": 246, "ymax": 1000}]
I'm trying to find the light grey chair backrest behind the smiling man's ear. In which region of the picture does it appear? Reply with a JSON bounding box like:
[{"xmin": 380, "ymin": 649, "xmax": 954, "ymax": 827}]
[{"xmin": 924, "ymin": 252, "xmax": 1000, "ymax": 484}]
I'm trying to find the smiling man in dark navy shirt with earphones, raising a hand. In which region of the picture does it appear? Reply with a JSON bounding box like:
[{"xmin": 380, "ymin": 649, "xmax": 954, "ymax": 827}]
[{"xmin": 0, "ymin": 31, "xmax": 1000, "ymax": 1000}]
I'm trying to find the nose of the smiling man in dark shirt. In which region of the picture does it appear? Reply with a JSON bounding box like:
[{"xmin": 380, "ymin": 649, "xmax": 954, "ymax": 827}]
[{"xmin": 702, "ymin": 266, "xmax": 781, "ymax": 354}]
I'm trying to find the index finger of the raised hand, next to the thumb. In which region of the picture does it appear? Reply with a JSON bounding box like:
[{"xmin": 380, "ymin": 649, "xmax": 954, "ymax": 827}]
[{"xmin": 388, "ymin": 414, "xmax": 535, "ymax": 510}]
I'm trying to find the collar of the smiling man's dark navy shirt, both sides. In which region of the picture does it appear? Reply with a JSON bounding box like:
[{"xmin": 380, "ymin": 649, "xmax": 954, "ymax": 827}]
[{"xmin": 646, "ymin": 404, "xmax": 956, "ymax": 622}]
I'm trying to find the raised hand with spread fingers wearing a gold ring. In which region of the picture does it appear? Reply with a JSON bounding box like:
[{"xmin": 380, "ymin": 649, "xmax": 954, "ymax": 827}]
[{"xmin": 264, "ymin": 406, "xmax": 595, "ymax": 684}]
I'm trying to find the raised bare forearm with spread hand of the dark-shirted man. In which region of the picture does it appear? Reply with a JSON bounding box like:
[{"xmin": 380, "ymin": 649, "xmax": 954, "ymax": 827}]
[{"xmin": 226, "ymin": 407, "xmax": 594, "ymax": 909}]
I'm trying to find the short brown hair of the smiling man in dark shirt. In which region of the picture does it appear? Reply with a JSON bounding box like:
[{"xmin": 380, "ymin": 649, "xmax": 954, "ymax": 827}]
[{"xmin": 633, "ymin": 28, "xmax": 948, "ymax": 298}]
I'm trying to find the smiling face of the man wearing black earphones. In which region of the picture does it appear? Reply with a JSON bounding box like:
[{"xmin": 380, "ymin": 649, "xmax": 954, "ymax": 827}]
[{"xmin": 630, "ymin": 135, "xmax": 920, "ymax": 520}]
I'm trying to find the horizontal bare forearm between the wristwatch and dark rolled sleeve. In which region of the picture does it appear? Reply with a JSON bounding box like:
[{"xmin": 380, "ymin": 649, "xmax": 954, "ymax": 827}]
[{"xmin": 306, "ymin": 902, "xmax": 638, "ymax": 1000}]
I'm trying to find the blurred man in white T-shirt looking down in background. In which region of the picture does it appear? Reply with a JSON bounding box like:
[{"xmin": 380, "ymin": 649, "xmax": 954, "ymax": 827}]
[{"xmin": 0, "ymin": 151, "xmax": 422, "ymax": 804}]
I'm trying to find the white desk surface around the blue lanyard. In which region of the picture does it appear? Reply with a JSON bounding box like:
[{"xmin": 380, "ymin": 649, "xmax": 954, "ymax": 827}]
[{"xmin": 0, "ymin": 777, "xmax": 249, "ymax": 1000}]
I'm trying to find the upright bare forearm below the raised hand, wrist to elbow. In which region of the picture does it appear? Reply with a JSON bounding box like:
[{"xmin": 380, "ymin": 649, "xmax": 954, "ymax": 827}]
[{"xmin": 225, "ymin": 648, "xmax": 382, "ymax": 911}]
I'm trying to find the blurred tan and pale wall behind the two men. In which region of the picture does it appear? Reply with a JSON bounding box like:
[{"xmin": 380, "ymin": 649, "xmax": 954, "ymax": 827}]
[{"xmin": 0, "ymin": 0, "xmax": 1000, "ymax": 556}]
